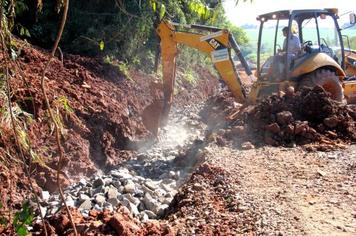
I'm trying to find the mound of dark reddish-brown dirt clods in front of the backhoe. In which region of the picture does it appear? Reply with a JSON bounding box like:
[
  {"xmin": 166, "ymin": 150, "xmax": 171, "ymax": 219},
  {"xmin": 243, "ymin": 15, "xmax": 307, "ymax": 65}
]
[{"xmin": 205, "ymin": 87, "xmax": 356, "ymax": 150}]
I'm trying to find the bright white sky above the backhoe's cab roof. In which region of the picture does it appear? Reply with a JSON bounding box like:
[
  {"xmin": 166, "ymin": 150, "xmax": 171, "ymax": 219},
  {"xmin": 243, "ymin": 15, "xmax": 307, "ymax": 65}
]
[{"xmin": 223, "ymin": 0, "xmax": 356, "ymax": 26}]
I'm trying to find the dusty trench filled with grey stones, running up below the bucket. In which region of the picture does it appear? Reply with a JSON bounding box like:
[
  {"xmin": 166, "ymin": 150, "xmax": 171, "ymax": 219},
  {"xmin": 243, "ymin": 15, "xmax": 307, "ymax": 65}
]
[{"xmin": 41, "ymin": 103, "xmax": 207, "ymax": 220}]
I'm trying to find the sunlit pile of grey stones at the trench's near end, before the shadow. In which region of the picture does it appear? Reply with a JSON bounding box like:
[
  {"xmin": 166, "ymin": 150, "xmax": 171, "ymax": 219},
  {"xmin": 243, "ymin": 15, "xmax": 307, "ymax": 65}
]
[{"xmin": 42, "ymin": 168, "xmax": 180, "ymax": 220}]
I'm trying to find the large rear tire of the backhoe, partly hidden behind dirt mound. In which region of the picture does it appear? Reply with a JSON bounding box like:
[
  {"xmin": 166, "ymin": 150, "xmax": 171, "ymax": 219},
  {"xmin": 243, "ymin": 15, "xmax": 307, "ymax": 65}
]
[{"xmin": 298, "ymin": 69, "xmax": 345, "ymax": 102}]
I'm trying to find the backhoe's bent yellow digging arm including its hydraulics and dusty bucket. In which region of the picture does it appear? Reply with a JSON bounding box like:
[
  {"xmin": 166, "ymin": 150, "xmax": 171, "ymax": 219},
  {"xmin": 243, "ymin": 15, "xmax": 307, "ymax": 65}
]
[{"xmin": 144, "ymin": 21, "xmax": 252, "ymax": 135}]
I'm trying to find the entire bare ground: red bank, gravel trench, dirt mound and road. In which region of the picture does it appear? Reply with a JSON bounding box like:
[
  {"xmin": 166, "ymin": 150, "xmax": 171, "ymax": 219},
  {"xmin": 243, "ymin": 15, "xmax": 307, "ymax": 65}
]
[{"xmin": 0, "ymin": 39, "xmax": 356, "ymax": 235}]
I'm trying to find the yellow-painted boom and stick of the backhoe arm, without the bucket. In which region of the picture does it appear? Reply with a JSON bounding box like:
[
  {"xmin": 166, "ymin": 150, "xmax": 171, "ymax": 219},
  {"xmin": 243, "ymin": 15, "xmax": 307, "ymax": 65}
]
[{"xmin": 157, "ymin": 22, "xmax": 245, "ymax": 105}]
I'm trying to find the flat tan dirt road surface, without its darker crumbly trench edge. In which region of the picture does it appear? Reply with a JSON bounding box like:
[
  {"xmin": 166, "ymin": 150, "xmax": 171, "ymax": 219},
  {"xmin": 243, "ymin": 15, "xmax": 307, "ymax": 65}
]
[{"xmin": 200, "ymin": 145, "xmax": 356, "ymax": 235}]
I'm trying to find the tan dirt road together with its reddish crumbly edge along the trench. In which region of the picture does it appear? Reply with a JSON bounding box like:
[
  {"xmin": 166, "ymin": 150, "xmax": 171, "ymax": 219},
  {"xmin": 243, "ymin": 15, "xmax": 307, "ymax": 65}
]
[{"xmin": 172, "ymin": 145, "xmax": 356, "ymax": 235}]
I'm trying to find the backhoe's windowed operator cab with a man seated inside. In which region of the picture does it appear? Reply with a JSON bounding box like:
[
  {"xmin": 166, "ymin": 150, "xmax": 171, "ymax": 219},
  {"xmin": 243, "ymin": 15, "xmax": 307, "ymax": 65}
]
[{"xmin": 257, "ymin": 9, "xmax": 345, "ymax": 81}]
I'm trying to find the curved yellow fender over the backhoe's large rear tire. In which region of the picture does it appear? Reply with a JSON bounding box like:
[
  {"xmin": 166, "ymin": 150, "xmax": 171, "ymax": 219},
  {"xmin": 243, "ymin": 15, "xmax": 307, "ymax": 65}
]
[{"xmin": 289, "ymin": 53, "xmax": 345, "ymax": 78}]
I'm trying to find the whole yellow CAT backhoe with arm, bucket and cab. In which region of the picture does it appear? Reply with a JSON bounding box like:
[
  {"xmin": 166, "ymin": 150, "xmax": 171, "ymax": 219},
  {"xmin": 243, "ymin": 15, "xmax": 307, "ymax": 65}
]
[{"xmin": 142, "ymin": 9, "xmax": 356, "ymax": 136}]
